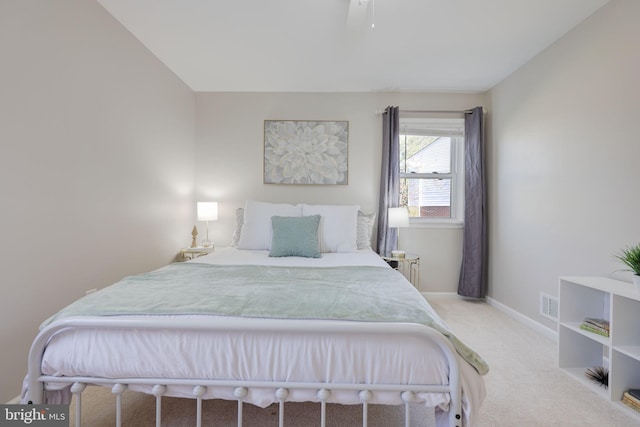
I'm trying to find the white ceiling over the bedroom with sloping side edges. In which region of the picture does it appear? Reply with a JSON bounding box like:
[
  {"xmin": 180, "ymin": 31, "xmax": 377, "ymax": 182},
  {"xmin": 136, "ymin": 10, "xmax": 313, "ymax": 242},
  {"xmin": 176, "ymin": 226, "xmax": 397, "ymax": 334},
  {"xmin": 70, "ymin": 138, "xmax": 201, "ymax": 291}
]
[{"xmin": 97, "ymin": 0, "xmax": 609, "ymax": 92}]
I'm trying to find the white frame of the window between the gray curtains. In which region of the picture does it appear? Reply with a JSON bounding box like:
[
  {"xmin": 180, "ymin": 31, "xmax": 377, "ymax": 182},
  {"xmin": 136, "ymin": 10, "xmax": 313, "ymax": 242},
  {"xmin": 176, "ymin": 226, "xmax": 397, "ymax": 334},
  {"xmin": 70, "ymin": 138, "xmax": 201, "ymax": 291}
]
[{"xmin": 398, "ymin": 116, "xmax": 464, "ymax": 228}]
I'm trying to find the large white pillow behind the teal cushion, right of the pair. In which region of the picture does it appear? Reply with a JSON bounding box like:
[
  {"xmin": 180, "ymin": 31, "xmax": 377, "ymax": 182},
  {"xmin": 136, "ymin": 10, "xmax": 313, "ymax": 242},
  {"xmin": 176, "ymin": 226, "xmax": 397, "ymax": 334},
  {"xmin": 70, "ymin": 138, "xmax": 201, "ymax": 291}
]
[{"xmin": 302, "ymin": 205, "xmax": 360, "ymax": 252}]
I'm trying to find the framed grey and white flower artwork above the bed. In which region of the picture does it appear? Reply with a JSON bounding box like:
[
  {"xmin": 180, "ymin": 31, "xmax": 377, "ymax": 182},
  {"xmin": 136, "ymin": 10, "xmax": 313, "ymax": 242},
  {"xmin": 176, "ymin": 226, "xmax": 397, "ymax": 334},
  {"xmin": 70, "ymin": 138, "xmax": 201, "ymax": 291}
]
[{"xmin": 264, "ymin": 120, "xmax": 349, "ymax": 185}]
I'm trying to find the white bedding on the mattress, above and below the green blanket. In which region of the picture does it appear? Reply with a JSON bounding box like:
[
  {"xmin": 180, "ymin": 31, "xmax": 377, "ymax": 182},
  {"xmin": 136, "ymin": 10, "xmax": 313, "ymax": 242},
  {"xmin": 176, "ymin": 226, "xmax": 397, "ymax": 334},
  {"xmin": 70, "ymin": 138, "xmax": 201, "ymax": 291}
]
[{"xmin": 31, "ymin": 248, "xmax": 485, "ymax": 425}]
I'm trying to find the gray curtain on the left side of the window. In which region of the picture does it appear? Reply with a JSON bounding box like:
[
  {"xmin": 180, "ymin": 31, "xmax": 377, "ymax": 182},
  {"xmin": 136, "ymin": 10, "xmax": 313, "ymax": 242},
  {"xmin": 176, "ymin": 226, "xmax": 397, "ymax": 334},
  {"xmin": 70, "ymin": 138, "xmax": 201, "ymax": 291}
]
[{"xmin": 378, "ymin": 106, "xmax": 400, "ymax": 254}]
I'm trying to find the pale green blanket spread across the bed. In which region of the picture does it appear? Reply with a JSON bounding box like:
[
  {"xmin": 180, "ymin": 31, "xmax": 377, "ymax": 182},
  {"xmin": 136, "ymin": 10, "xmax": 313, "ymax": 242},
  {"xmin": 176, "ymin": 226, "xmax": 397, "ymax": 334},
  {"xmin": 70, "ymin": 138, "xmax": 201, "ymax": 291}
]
[{"xmin": 41, "ymin": 263, "xmax": 489, "ymax": 375}]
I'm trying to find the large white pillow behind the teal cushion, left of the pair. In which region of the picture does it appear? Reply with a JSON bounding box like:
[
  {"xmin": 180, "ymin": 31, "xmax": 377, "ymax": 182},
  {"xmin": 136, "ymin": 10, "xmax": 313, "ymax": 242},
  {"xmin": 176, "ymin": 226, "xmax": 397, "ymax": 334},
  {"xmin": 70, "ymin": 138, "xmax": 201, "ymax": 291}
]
[{"xmin": 238, "ymin": 200, "xmax": 302, "ymax": 250}]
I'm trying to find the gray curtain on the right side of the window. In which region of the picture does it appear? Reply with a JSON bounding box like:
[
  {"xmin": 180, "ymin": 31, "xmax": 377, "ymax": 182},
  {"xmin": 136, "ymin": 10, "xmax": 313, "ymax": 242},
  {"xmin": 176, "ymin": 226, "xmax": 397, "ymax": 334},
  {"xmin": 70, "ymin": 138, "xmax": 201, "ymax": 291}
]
[{"xmin": 458, "ymin": 107, "xmax": 487, "ymax": 298}]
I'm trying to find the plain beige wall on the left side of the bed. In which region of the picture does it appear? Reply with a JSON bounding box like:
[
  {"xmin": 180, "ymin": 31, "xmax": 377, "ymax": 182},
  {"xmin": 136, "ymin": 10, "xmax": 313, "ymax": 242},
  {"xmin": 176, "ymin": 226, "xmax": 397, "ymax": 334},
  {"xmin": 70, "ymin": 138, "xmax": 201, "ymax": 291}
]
[{"xmin": 0, "ymin": 0, "xmax": 195, "ymax": 402}]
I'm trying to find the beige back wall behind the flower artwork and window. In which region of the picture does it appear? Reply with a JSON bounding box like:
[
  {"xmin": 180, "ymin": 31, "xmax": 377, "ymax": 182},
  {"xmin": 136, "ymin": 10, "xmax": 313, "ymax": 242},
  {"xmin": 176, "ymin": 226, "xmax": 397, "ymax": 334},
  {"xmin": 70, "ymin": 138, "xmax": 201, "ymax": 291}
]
[{"xmin": 195, "ymin": 93, "xmax": 486, "ymax": 292}]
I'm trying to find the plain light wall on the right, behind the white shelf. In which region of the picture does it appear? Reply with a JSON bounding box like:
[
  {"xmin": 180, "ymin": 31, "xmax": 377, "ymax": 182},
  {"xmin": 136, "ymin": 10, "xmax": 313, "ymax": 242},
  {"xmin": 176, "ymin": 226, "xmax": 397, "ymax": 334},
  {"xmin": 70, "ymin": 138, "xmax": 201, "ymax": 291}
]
[{"xmin": 488, "ymin": 0, "xmax": 640, "ymax": 330}]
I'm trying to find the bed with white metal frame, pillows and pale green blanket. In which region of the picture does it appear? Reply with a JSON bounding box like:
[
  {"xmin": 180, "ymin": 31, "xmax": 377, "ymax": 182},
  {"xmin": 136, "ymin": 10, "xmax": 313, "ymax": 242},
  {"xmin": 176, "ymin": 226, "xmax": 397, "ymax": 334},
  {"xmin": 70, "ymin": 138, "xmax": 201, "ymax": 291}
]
[{"xmin": 23, "ymin": 201, "xmax": 488, "ymax": 426}]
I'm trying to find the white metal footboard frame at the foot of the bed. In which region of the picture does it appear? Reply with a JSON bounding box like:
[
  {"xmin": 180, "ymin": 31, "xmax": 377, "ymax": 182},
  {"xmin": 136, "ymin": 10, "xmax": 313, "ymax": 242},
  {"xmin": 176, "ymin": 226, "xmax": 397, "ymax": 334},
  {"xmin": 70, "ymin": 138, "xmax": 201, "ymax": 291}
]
[{"xmin": 28, "ymin": 317, "xmax": 462, "ymax": 427}]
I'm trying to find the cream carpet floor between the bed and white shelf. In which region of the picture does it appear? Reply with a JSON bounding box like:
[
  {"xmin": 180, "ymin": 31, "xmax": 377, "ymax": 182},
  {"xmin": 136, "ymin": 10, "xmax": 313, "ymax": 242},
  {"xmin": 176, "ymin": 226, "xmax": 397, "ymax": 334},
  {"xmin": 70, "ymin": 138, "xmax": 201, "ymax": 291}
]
[{"xmin": 428, "ymin": 295, "xmax": 640, "ymax": 427}]
